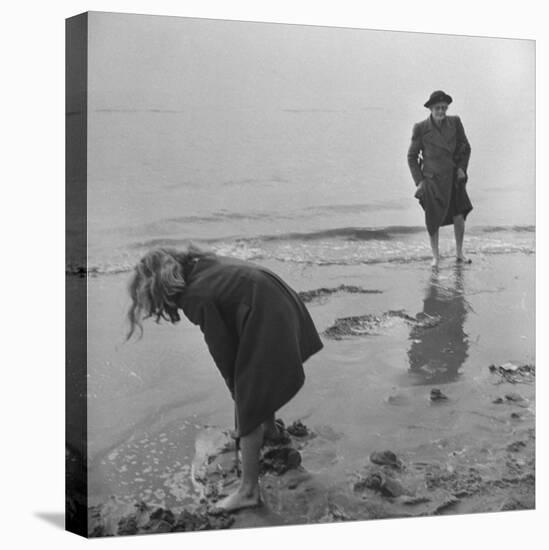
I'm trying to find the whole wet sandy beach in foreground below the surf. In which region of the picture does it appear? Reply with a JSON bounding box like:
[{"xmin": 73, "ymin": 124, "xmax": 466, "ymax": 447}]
[{"xmin": 83, "ymin": 254, "xmax": 535, "ymax": 535}]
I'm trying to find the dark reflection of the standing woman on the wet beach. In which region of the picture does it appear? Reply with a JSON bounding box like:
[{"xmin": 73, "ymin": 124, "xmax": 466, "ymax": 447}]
[{"xmin": 408, "ymin": 266, "xmax": 471, "ymax": 384}]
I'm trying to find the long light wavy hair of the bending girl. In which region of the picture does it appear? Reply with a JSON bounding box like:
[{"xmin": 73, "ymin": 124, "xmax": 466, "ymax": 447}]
[{"xmin": 126, "ymin": 243, "xmax": 214, "ymax": 341}]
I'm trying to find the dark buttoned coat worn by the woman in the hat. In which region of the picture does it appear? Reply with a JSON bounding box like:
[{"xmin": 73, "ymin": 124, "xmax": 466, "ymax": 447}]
[{"xmin": 408, "ymin": 116, "xmax": 473, "ymax": 235}]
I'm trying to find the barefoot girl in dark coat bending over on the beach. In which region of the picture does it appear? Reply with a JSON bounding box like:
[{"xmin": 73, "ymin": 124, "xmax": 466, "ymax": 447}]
[{"xmin": 126, "ymin": 245, "xmax": 323, "ymax": 512}]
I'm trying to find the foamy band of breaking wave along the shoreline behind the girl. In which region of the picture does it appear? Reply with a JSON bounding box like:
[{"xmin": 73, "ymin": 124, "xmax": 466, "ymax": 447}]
[{"xmin": 73, "ymin": 226, "xmax": 535, "ymax": 276}]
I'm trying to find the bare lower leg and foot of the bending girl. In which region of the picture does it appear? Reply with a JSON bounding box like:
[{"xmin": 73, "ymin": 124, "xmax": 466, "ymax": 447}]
[{"xmin": 215, "ymin": 424, "xmax": 264, "ymax": 512}]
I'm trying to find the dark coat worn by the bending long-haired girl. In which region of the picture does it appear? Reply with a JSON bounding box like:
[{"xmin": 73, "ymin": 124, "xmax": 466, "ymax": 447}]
[{"xmin": 178, "ymin": 255, "xmax": 323, "ymax": 437}]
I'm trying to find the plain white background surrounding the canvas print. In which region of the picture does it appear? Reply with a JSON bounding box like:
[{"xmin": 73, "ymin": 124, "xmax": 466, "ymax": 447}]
[{"xmin": 0, "ymin": 0, "xmax": 549, "ymax": 550}]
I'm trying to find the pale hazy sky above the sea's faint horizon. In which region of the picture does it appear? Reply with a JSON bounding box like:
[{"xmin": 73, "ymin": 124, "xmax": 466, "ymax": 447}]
[{"xmin": 89, "ymin": 12, "xmax": 535, "ymax": 117}]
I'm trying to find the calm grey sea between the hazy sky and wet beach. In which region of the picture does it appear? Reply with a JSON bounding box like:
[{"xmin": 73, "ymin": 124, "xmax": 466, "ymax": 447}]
[{"xmin": 79, "ymin": 108, "xmax": 535, "ymax": 275}]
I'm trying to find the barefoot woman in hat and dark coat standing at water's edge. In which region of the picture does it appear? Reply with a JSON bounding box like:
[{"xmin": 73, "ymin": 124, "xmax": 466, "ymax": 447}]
[{"xmin": 408, "ymin": 90, "xmax": 473, "ymax": 268}]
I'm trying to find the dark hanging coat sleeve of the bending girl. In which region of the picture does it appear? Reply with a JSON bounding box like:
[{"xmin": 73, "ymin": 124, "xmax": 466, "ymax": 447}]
[{"xmin": 184, "ymin": 299, "xmax": 237, "ymax": 398}]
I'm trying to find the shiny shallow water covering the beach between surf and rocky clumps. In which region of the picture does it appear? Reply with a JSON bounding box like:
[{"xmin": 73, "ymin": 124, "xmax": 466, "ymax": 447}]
[{"xmin": 88, "ymin": 252, "xmax": 535, "ymax": 516}]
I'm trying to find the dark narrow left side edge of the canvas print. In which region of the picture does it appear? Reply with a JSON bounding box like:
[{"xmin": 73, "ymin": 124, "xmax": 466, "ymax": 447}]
[{"xmin": 65, "ymin": 13, "xmax": 88, "ymax": 537}]
